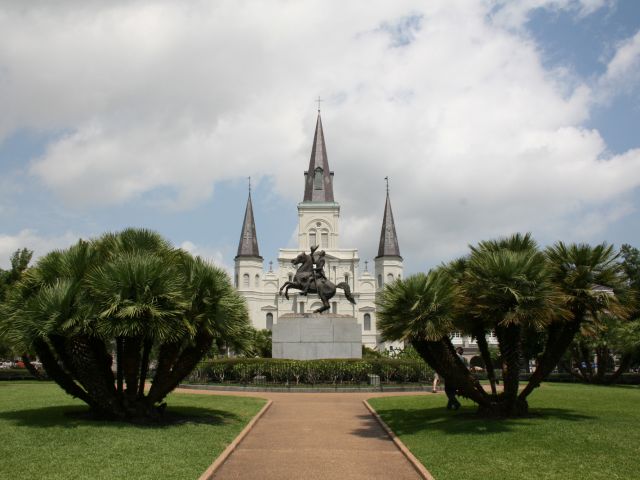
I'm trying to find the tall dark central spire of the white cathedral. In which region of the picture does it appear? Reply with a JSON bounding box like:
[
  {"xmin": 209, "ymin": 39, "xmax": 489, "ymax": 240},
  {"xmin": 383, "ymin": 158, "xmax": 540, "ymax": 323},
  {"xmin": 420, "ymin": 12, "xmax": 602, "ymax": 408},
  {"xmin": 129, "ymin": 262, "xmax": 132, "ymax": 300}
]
[{"xmin": 303, "ymin": 109, "xmax": 334, "ymax": 202}]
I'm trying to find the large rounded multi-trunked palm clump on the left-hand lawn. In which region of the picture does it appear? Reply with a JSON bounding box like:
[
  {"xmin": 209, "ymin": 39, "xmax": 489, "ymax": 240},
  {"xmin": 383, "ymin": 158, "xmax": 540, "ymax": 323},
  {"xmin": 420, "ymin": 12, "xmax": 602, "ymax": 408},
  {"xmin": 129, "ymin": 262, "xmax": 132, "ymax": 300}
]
[{"xmin": 0, "ymin": 229, "xmax": 250, "ymax": 420}]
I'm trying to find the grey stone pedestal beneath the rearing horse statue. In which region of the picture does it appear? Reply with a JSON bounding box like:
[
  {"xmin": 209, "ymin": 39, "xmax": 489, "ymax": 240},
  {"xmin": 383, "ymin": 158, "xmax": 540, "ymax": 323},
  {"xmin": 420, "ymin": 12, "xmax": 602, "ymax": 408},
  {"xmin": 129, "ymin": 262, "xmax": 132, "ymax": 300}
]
[{"xmin": 272, "ymin": 313, "xmax": 362, "ymax": 360}]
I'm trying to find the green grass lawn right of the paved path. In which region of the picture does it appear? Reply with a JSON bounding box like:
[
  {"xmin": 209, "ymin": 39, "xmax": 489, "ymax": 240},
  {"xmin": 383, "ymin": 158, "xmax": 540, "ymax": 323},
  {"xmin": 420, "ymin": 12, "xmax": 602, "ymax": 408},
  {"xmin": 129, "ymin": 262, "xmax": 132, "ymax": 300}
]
[{"xmin": 369, "ymin": 383, "xmax": 640, "ymax": 480}]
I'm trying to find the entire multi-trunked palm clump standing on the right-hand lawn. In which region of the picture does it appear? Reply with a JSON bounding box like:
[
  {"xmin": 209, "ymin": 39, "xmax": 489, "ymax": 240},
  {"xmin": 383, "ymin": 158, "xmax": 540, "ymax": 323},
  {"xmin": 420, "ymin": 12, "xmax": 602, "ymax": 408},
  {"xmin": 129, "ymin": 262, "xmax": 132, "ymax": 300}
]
[{"xmin": 378, "ymin": 234, "xmax": 628, "ymax": 417}]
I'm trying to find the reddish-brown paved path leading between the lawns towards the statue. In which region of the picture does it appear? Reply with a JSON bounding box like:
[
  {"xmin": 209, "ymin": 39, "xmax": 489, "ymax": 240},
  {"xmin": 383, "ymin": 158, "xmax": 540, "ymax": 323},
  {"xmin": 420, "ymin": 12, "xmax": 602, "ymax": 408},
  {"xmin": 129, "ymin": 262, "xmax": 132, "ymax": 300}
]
[{"xmin": 176, "ymin": 390, "xmax": 430, "ymax": 480}]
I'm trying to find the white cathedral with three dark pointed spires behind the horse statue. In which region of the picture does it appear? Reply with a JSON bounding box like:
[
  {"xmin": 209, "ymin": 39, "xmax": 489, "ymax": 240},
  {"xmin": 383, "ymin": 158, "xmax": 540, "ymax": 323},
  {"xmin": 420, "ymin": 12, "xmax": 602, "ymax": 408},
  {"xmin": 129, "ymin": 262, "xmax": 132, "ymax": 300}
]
[{"xmin": 234, "ymin": 111, "xmax": 403, "ymax": 350}]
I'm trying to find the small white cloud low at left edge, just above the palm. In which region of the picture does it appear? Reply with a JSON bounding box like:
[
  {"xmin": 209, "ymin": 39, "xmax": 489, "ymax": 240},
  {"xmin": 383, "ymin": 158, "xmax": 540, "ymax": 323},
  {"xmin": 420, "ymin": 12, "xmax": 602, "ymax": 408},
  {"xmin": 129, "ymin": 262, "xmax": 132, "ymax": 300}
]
[{"xmin": 0, "ymin": 229, "xmax": 79, "ymax": 269}]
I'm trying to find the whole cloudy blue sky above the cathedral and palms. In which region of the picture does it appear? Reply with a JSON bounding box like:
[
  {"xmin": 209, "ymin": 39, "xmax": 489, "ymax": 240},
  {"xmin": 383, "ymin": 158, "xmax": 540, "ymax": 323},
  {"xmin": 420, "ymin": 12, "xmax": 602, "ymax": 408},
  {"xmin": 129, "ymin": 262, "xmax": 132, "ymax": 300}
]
[{"xmin": 0, "ymin": 0, "xmax": 640, "ymax": 273}]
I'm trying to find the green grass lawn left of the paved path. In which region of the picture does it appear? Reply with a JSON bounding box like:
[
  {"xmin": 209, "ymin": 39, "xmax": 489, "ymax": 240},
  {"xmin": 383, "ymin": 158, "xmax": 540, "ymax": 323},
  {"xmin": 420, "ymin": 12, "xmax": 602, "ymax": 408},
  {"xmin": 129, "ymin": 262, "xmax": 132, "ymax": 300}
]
[{"xmin": 0, "ymin": 381, "xmax": 266, "ymax": 480}]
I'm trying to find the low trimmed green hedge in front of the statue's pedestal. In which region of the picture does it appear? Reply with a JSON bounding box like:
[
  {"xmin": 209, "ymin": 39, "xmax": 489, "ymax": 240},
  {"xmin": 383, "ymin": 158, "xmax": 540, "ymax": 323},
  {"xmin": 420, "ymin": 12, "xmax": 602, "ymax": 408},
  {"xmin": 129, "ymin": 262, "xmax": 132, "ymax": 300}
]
[{"xmin": 189, "ymin": 358, "xmax": 433, "ymax": 385}]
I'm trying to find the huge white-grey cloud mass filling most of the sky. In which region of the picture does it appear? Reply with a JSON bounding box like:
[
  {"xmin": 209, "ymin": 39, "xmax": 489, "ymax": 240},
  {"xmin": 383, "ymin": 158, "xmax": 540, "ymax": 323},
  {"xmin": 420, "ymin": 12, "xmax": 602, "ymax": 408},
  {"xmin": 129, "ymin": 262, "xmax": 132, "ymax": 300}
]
[{"xmin": 0, "ymin": 0, "xmax": 640, "ymax": 263}]
